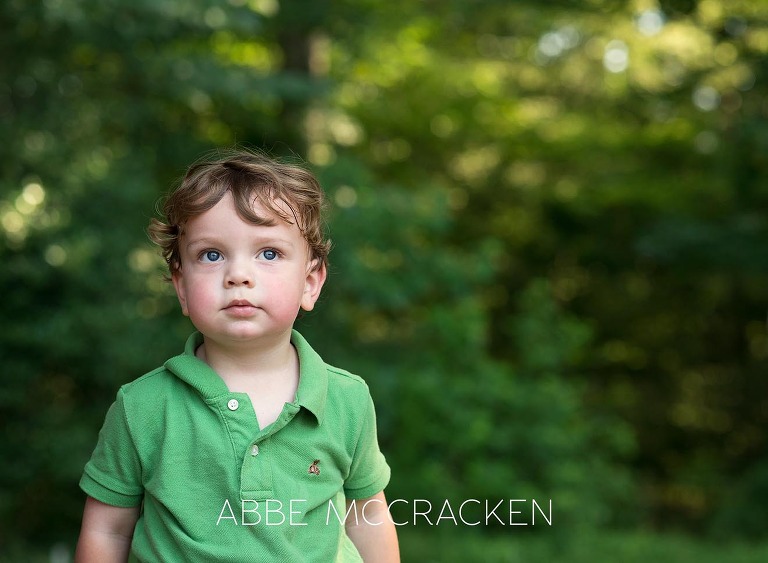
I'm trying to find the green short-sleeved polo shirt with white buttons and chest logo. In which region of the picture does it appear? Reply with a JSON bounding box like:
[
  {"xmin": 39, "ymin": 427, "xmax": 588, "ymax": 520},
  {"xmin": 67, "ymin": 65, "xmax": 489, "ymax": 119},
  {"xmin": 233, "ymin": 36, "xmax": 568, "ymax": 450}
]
[{"xmin": 80, "ymin": 331, "xmax": 390, "ymax": 563}]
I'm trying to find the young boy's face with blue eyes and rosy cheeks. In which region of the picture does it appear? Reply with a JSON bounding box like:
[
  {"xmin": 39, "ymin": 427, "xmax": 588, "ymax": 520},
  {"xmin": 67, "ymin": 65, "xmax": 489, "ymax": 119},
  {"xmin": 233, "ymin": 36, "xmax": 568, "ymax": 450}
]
[{"xmin": 173, "ymin": 192, "xmax": 326, "ymax": 345}]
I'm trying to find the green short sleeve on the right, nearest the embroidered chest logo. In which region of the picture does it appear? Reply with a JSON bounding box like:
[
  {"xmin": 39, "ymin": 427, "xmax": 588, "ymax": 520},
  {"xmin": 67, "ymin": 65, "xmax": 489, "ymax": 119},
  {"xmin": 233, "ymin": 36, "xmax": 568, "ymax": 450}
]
[{"xmin": 344, "ymin": 393, "xmax": 390, "ymax": 499}]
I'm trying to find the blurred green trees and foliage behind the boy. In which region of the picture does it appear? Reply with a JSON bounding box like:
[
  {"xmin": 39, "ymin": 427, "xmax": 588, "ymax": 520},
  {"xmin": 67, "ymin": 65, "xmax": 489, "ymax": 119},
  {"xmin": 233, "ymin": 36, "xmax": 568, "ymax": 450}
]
[{"xmin": 0, "ymin": 0, "xmax": 768, "ymax": 561}]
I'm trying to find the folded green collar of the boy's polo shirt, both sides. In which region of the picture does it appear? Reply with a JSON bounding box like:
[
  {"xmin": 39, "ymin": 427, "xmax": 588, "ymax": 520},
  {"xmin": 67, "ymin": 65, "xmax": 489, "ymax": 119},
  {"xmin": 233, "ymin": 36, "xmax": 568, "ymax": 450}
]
[{"xmin": 165, "ymin": 330, "xmax": 328, "ymax": 424}]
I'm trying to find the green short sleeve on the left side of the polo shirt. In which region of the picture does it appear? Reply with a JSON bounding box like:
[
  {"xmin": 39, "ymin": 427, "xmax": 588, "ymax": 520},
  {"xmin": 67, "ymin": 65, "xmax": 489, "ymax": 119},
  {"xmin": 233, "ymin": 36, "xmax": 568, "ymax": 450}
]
[{"xmin": 80, "ymin": 390, "xmax": 143, "ymax": 507}]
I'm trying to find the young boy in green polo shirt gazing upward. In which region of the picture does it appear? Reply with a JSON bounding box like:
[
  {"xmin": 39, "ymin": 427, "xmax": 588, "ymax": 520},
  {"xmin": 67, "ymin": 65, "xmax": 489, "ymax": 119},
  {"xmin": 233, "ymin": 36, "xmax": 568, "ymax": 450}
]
[{"xmin": 76, "ymin": 151, "xmax": 399, "ymax": 563}]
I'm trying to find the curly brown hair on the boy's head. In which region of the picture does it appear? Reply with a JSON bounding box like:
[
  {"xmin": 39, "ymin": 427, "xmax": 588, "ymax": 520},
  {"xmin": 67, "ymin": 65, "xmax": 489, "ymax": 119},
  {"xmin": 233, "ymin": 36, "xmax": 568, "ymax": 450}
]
[{"xmin": 148, "ymin": 149, "xmax": 331, "ymax": 274}]
